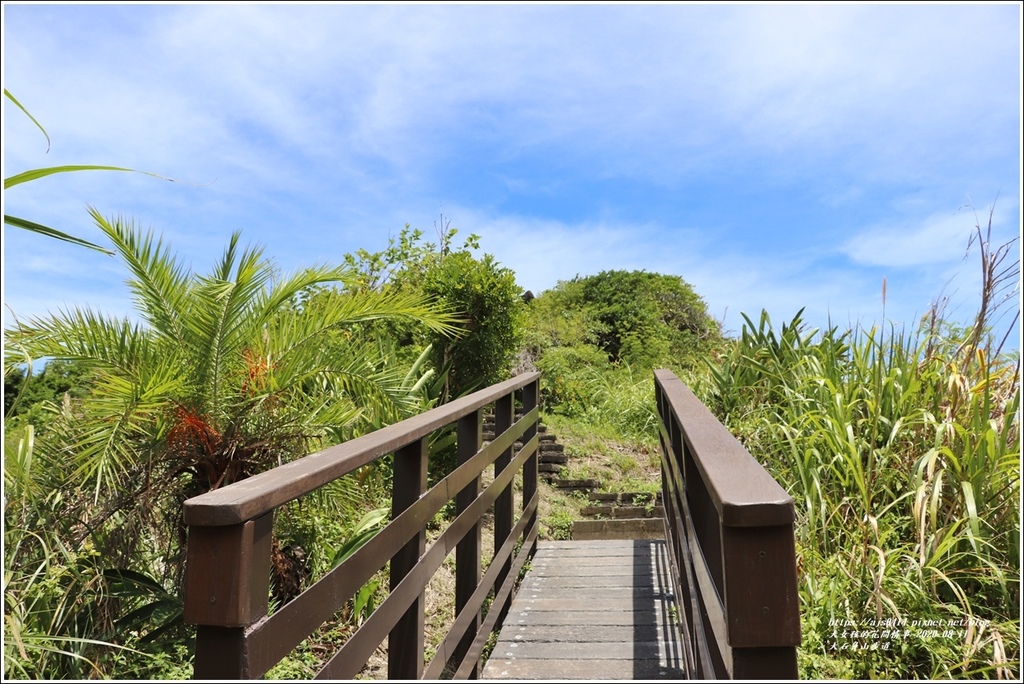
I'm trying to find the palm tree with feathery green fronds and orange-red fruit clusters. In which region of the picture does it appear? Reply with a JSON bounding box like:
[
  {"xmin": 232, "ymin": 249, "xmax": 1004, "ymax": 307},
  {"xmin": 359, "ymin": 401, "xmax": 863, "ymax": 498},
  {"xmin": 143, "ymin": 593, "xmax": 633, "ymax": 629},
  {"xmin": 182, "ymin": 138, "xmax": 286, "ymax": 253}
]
[{"xmin": 5, "ymin": 210, "xmax": 455, "ymax": 528}]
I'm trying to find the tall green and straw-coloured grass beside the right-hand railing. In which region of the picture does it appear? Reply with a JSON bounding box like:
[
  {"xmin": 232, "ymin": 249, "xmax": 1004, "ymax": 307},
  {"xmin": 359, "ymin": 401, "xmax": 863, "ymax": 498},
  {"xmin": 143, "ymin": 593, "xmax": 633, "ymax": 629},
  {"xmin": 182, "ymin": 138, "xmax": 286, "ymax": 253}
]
[{"xmin": 711, "ymin": 276, "xmax": 1021, "ymax": 679}]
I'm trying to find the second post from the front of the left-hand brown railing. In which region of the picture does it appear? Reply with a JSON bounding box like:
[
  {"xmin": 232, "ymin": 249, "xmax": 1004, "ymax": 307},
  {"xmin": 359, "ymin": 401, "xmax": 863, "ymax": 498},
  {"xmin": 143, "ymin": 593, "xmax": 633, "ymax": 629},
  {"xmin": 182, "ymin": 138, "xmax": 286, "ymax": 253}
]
[{"xmin": 387, "ymin": 437, "xmax": 427, "ymax": 680}]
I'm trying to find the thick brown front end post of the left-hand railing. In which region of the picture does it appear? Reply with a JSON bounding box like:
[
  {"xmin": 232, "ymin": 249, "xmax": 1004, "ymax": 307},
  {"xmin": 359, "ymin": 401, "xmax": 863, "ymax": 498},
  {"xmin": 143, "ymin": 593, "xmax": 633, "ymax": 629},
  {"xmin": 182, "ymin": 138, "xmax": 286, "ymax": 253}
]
[{"xmin": 184, "ymin": 512, "xmax": 273, "ymax": 679}]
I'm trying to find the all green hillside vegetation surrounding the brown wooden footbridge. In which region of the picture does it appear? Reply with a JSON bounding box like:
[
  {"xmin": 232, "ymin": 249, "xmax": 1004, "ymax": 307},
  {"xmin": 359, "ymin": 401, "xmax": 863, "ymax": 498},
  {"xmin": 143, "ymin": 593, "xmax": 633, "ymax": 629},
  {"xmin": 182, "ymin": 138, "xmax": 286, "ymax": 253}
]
[{"xmin": 4, "ymin": 209, "xmax": 1021, "ymax": 679}]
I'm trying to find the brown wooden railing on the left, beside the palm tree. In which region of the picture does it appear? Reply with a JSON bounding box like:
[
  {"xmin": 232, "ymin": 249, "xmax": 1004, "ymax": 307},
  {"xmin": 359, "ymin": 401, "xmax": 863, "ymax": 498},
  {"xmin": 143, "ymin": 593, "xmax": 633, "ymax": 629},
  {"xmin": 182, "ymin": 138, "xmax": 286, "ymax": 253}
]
[{"xmin": 184, "ymin": 373, "xmax": 540, "ymax": 679}]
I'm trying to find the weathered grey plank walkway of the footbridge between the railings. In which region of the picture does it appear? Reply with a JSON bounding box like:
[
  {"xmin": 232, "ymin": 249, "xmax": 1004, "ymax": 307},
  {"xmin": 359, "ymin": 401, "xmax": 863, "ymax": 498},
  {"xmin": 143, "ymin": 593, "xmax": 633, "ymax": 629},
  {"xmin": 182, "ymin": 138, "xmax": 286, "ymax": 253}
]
[{"xmin": 482, "ymin": 540, "xmax": 684, "ymax": 681}]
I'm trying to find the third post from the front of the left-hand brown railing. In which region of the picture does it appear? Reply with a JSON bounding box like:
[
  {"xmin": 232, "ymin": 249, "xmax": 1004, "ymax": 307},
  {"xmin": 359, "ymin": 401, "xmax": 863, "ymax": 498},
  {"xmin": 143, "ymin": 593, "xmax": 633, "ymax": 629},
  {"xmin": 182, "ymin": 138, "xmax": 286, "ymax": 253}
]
[{"xmin": 454, "ymin": 409, "xmax": 483, "ymax": 679}]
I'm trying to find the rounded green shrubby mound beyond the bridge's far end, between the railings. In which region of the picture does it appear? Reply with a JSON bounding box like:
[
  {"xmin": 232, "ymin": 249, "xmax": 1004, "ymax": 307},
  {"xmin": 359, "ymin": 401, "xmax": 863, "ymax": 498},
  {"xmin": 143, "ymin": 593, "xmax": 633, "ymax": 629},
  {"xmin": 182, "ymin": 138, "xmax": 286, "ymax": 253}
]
[{"xmin": 524, "ymin": 270, "xmax": 723, "ymax": 440}]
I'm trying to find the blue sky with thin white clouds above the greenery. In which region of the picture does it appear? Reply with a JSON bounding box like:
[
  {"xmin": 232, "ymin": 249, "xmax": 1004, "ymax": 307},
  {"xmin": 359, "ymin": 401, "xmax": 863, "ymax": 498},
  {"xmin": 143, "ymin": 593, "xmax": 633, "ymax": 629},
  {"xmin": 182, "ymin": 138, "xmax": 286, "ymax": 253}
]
[{"xmin": 3, "ymin": 3, "xmax": 1021, "ymax": 348}]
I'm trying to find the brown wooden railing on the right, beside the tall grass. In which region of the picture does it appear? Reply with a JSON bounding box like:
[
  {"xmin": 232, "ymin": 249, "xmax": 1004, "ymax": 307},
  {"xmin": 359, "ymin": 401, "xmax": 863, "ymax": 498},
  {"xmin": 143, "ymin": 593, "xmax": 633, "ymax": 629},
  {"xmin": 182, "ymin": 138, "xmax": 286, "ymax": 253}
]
[{"xmin": 654, "ymin": 371, "xmax": 800, "ymax": 679}]
